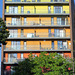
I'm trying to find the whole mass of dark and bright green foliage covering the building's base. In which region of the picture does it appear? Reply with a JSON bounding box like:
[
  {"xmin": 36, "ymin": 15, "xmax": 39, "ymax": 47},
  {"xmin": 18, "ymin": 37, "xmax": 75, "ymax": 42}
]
[{"xmin": 14, "ymin": 52, "xmax": 72, "ymax": 75}]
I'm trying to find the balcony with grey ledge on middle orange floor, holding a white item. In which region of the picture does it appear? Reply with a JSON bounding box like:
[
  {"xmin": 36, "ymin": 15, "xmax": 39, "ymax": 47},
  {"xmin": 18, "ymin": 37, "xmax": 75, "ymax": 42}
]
[{"xmin": 8, "ymin": 32, "xmax": 70, "ymax": 39}]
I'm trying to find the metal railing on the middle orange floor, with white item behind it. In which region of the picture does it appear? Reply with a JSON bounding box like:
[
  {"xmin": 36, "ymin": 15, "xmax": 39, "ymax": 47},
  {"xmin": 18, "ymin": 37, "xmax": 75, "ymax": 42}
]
[{"xmin": 9, "ymin": 32, "xmax": 70, "ymax": 38}]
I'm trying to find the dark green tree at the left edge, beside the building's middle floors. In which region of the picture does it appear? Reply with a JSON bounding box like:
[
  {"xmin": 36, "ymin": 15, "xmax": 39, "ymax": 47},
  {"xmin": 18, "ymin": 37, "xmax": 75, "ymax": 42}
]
[{"xmin": 0, "ymin": 18, "xmax": 9, "ymax": 44}]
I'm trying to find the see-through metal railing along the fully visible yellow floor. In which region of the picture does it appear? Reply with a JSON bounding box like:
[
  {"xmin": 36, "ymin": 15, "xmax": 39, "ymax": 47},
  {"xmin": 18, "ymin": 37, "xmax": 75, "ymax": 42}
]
[{"xmin": 5, "ymin": 9, "xmax": 69, "ymax": 14}]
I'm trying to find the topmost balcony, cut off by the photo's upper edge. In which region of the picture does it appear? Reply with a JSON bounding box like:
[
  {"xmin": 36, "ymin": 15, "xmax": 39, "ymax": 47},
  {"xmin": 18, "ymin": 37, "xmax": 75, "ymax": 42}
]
[{"xmin": 5, "ymin": 0, "xmax": 69, "ymax": 4}]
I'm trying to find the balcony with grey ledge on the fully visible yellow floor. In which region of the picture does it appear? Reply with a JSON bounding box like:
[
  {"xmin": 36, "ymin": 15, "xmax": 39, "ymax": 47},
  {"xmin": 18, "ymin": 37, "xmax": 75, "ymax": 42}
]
[{"xmin": 5, "ymin": 9, "xmax": 69, "ymax": 15}]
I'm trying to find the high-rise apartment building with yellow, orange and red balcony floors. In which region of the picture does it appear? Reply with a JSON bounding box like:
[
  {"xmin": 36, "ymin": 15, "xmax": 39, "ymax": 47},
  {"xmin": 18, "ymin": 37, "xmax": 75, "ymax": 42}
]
[{"xmin": 2, "ymin": 0, "xmax": 73, "ymax": 75}]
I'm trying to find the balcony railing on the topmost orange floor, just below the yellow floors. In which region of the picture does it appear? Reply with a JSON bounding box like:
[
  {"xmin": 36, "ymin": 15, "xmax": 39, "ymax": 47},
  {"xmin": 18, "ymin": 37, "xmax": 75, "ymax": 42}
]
[{"xmin": 5, "ymin": 20, "xmax": 70, "ymax": 26}]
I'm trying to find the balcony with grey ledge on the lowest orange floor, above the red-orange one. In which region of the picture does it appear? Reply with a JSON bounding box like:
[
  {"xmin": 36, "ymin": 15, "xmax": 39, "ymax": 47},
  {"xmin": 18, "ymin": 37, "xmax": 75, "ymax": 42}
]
[{"xmin": 4, "ymin": 45, "xmax": 71, "ymax": 52}]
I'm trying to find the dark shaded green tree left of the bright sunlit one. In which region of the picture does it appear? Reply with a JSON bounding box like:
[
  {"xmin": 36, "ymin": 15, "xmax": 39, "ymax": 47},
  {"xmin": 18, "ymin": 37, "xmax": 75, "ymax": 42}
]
[{"xmin": 13, "ymin": 59, "xmax": 33, "ymax": 75}]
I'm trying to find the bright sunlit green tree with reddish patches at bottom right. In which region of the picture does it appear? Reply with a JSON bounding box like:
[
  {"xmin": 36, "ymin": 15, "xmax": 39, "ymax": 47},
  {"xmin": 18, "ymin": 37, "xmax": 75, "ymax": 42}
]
[{"xmin": 32, "ymin": 52, "xmax": 72, "ymax": 75}]
